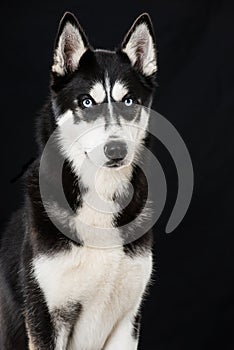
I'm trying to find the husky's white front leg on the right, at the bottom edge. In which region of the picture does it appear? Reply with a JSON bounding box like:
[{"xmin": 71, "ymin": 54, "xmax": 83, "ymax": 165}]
[{"xmin": 103, "ymin": 313, "xmax": 139, "ymax": 350}]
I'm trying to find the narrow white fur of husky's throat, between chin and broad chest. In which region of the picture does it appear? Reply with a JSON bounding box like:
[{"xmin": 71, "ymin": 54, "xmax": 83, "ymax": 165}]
[{"xmin": 71, "ymin": 164, "xmax": 131, "ymax": 248}]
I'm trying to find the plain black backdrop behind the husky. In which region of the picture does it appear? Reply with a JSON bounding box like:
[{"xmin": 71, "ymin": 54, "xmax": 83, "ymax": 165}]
[{"xmin": 0, "ymin": 0, "xmax": 234, "ymax": 350}]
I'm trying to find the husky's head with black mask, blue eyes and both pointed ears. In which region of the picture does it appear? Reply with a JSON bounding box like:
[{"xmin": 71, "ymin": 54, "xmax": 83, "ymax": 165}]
[{"xmin": 52, "ymin": 13, "xmax": 157, "ymax": 189}]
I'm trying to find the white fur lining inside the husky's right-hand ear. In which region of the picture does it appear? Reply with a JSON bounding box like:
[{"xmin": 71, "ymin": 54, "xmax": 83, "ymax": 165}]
[{"xmin": 123, "ymin": 23, "xmax": 157, "ymax": 76}]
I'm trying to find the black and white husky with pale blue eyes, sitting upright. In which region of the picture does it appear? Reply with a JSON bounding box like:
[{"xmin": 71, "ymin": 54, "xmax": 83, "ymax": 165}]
[{"xmin": 0, "ymin": 13, "xmax": 157, "ymax": 350}]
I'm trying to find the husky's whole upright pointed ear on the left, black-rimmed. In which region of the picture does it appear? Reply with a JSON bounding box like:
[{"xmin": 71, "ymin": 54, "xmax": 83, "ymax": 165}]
[{"xmin": 52, "ymin": 12, "xmax": 89, "ymax": 76}]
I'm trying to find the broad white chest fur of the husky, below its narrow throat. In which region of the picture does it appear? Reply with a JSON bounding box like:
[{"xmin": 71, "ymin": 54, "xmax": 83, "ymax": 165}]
[{"xmin": 33, "ymin": 246, "xmax": 152, "ymax": 350}]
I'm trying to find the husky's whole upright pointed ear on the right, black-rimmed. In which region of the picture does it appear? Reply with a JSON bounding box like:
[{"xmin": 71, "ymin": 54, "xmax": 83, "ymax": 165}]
[{"xmin": 121, "ymin": 13, "xmax": 157, "ymax": 76}]
